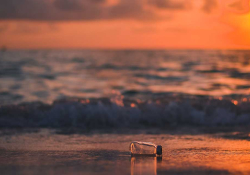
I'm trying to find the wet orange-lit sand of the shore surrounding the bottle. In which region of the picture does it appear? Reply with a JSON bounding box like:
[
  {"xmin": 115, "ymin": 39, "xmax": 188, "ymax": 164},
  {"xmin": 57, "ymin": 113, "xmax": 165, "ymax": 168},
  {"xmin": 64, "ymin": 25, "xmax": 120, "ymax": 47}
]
[{"xmin": 0, "ymin": 130, "xmax": 250, "ymax": 175}]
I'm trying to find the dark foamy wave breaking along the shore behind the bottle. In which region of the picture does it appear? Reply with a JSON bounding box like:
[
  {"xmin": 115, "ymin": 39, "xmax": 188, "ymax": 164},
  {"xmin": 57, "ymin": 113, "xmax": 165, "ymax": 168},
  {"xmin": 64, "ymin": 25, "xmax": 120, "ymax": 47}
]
[{"xmin": 0, "ymin": 95, "xmax": 250, "ymax": 130}]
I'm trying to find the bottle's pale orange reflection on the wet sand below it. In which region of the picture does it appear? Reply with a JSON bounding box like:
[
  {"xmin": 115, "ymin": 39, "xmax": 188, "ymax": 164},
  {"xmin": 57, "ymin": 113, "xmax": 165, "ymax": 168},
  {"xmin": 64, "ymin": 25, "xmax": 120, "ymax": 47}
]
[{"xmin": 131, "ymin": 156, "xmax": 162, "ymax": 175}]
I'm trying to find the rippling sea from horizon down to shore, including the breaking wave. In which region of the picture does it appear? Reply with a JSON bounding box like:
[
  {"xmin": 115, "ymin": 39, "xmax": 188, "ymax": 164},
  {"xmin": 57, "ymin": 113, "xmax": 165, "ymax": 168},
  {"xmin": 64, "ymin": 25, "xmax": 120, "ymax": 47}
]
[{"xmin": 0, "ymin": 50, "xmax": 250, "ymax": 130}]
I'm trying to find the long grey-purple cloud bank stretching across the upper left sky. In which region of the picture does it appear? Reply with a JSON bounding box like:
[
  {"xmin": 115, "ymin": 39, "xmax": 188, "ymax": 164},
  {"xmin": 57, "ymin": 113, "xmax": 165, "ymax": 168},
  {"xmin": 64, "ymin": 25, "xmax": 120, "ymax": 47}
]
[{"xmin": 0, "ymin": 0, "xmax": 187, "ymax": 21}]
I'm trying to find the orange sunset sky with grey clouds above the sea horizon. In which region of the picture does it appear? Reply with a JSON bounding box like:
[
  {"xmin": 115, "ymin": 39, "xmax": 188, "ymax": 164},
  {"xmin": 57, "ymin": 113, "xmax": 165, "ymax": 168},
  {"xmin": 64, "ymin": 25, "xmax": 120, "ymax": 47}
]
[{"xmin": 0, "ymin": 0, "xmax": 250, "ymax": 49}]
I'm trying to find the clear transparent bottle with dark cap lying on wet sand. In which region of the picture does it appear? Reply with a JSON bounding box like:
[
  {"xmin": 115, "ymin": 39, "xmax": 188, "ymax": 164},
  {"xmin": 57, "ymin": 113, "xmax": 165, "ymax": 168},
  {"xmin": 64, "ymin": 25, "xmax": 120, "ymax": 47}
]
[{"xmin": 129, "ymin": 141, "xmax": 162, "ymax": 156}]
